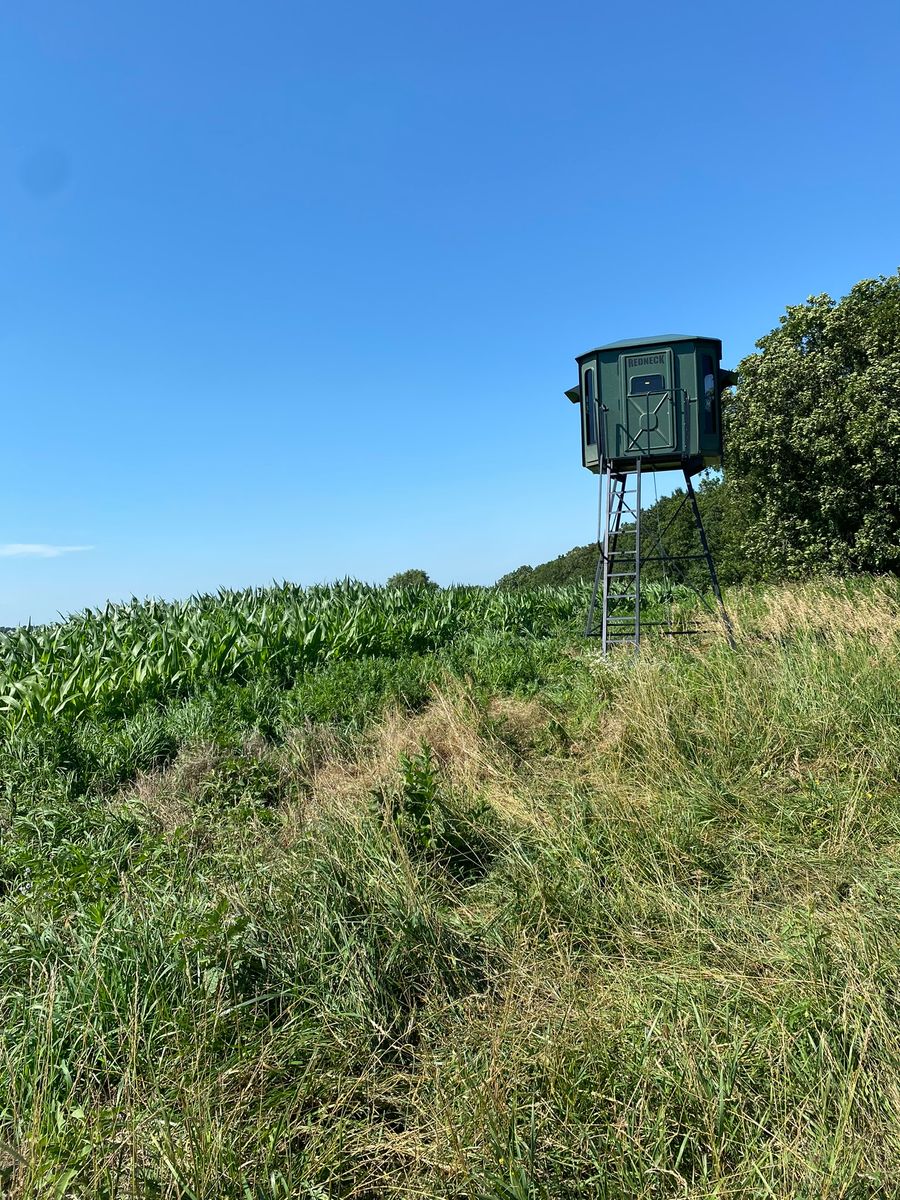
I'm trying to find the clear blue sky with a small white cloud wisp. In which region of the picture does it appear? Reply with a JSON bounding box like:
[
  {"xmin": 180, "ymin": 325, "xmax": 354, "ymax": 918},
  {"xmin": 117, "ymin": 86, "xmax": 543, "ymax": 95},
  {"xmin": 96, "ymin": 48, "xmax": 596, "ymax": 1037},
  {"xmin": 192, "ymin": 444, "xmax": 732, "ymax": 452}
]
[{"xmin": 0, "ymin": 0, "xmax": 900, "ymax": 624}]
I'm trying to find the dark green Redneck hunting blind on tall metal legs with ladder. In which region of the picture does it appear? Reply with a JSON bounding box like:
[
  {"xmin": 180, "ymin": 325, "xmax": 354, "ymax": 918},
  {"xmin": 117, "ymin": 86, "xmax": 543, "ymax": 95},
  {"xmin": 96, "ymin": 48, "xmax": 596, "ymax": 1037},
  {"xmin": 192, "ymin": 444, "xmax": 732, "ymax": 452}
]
[{"xmin": 566, "ymin": 334, "xmax": 734, "ymax": 653}]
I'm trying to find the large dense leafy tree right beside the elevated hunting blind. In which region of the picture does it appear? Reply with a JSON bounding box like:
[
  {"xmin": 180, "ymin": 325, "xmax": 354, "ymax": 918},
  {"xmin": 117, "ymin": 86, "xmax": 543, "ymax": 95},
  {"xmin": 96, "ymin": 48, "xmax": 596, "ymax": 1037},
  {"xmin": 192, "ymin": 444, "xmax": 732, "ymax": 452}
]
[{"xmin": 725, "ymin": 272, "xmax": 900, "ymax": 574}]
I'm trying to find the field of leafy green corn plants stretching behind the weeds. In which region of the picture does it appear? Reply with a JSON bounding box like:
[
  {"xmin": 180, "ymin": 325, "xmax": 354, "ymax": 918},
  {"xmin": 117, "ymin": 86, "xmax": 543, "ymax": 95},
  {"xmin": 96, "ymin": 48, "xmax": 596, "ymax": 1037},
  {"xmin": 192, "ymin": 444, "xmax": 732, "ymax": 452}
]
[{"xmin": 0, "ymin": 581, "xmax": 696, "ymax": 733}]
